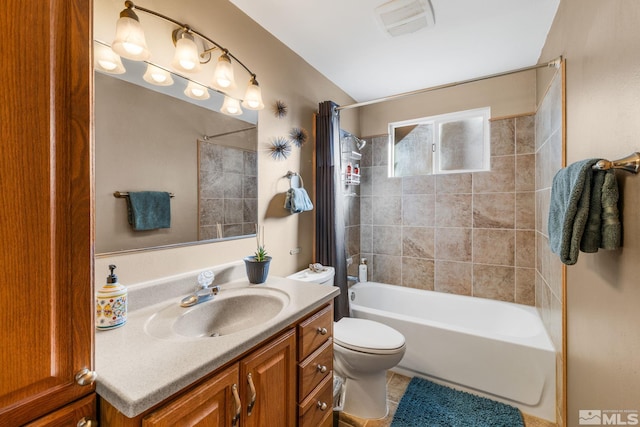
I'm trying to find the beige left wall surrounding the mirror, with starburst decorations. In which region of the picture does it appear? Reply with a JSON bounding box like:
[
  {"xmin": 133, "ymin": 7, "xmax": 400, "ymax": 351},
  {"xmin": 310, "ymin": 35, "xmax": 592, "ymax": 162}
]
[{"xmin": 95, "ymin": 0, "xmax": 359, "ymax": 285}]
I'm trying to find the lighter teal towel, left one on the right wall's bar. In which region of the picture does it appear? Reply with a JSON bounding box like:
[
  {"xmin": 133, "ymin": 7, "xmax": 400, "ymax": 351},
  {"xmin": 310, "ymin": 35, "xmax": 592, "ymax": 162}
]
[{"xmin": 549, "ymin": 159, "xmax": 600, "ymax": 265}]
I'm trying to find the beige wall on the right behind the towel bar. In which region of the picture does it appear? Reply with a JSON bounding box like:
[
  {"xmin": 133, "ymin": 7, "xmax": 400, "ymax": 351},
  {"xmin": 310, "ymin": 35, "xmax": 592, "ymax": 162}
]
[{"xmin": 541, "ymin": 0, "xmax": 640, "ymax": 426}]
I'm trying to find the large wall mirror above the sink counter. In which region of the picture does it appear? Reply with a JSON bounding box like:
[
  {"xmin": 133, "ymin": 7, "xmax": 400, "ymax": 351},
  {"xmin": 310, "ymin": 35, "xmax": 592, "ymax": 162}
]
[{"xmin": 95, "ymin": 47, "xmax": 258, "ymax": 255}]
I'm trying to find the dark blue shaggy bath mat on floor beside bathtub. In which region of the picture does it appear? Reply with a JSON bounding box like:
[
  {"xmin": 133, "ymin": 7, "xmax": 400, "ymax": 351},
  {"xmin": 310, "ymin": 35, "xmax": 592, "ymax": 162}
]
[{"xmin": 391, "ymin": 377, "xmax": 524, "ymax": 427}]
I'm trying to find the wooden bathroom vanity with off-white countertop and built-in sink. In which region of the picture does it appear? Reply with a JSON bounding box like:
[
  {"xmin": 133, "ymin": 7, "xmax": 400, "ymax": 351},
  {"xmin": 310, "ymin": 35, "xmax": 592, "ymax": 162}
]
[{"xmin": 96, "ymin": 268, "xmax": 339, "ymax": 427}]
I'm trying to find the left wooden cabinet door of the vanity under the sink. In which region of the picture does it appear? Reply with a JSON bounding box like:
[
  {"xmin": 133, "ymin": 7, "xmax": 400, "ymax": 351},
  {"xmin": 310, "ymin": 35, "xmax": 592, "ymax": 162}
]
[{"xmin": 142, "ymin": 364, "xmax": 241, "ymax": 427}]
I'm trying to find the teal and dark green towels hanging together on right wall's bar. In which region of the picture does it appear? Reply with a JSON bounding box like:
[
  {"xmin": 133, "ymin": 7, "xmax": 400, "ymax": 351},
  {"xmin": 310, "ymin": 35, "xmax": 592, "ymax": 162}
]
[{"xmin": 549, "ymin": 159, "xmax": 621, "ymax": 265}]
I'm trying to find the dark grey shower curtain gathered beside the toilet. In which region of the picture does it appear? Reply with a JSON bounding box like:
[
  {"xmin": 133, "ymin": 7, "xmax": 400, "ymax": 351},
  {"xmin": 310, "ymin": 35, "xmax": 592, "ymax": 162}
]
[{"xmin": 316, "ymin": 101, "xmax": 349, "ymax": 321}]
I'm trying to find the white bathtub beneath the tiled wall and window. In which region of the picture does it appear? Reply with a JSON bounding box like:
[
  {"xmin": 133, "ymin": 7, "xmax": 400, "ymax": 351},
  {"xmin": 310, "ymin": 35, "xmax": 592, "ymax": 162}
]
[{"xmin": 349, "ymin": 282, "xmax": 556, "ymax": 421}]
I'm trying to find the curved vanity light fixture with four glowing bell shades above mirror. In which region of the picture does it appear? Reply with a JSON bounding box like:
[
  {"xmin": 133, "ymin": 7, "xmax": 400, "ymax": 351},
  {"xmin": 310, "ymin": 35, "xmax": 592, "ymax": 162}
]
[{"xmin": 112, "ymin": 0, "xmax": 264, "ymax": 110}]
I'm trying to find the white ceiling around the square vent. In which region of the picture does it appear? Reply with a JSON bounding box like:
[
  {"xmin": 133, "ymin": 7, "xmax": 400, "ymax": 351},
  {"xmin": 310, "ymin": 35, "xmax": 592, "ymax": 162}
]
[{"xmin": 230, "ymin": 0, "xmax": 559, "ymax": 102}]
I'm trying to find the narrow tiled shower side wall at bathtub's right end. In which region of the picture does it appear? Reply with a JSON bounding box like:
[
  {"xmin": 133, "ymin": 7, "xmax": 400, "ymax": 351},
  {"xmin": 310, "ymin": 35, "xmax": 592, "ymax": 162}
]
[{"xmin": 535, "ymin": 73, "xmax": 564, "ymax": 426}]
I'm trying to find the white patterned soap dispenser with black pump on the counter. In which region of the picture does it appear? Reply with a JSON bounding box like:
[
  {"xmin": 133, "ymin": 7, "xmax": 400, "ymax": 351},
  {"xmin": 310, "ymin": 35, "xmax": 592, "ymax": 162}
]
[{"xmin": 96, "ymin": 264, "xmax": 127, "ymax": 330}]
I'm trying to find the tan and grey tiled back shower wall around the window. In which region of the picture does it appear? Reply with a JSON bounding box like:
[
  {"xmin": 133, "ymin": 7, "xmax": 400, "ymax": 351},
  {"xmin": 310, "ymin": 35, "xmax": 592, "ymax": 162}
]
[{"xmin": 345, "ymin": 115, "xmax": 536, "ymax": 305}]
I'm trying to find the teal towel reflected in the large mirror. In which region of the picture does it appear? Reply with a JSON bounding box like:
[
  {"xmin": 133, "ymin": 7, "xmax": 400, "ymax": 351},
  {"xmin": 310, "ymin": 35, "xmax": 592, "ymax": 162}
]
[{"xmin": 127, "ymin": 191, "xmax": 171, "ymax": 231}]
